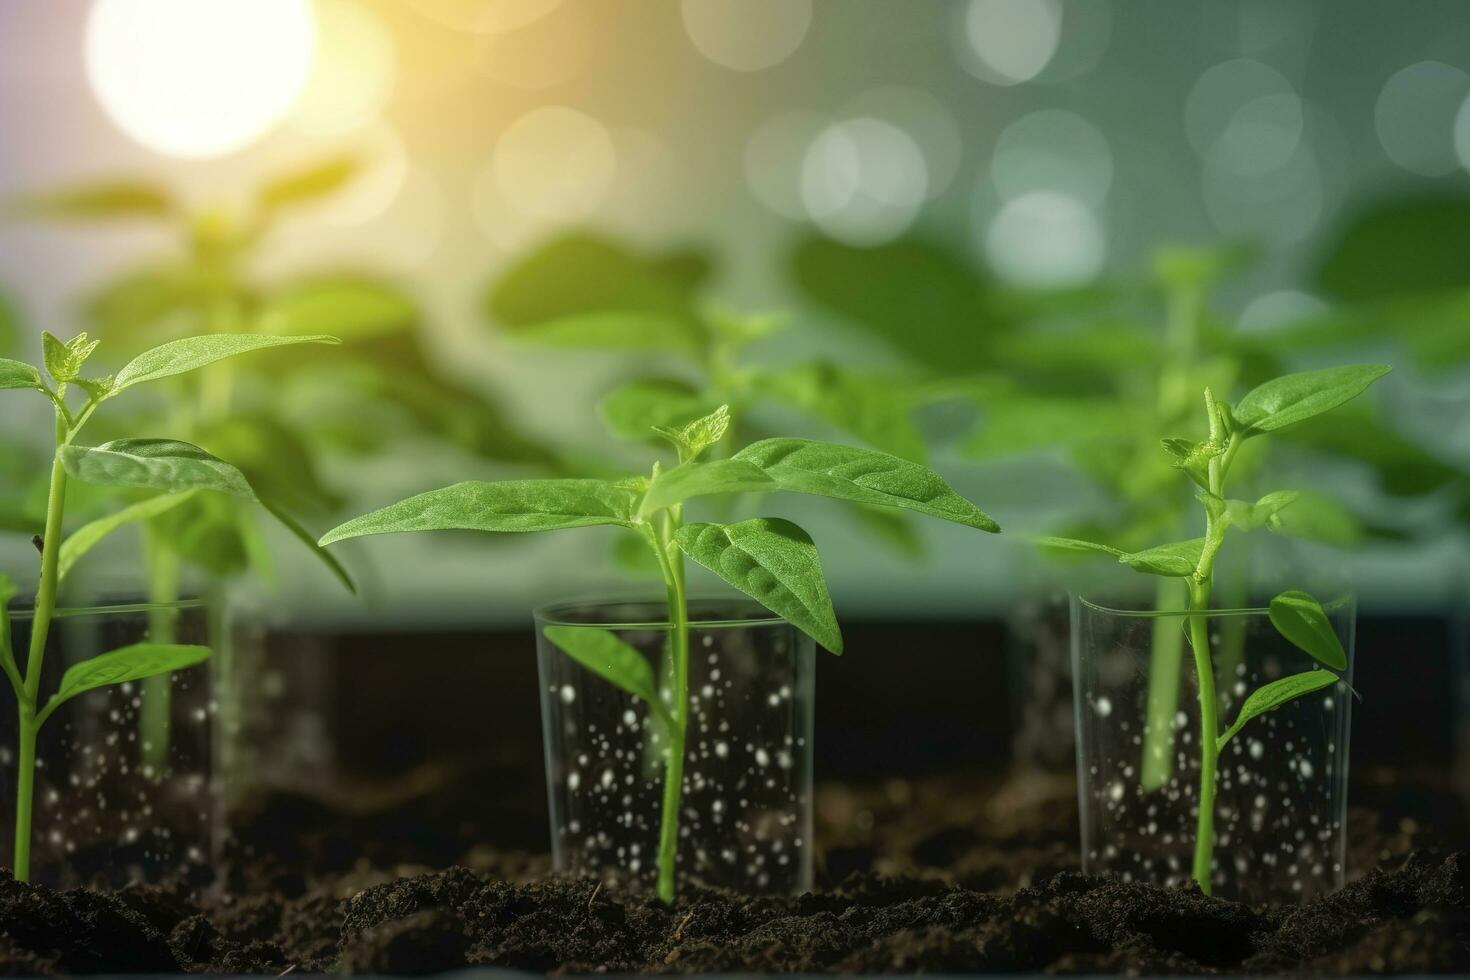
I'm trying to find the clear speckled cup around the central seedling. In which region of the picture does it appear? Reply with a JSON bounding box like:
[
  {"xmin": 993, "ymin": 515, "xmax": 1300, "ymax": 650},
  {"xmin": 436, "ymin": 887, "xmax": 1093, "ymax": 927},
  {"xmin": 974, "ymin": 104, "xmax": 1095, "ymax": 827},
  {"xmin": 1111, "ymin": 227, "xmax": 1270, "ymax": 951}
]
[{"xmin": 535, "ymin": 599, "xmax": 814, "ymax": 895}]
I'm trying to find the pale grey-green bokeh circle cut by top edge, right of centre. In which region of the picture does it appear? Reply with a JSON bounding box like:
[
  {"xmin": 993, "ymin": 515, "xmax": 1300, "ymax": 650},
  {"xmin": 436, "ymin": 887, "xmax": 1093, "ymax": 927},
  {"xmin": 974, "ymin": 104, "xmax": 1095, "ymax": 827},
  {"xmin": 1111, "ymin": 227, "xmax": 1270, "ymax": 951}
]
[{"xmin": 961, "ymin": 0, "xmax": 1063, "ymax": 85}]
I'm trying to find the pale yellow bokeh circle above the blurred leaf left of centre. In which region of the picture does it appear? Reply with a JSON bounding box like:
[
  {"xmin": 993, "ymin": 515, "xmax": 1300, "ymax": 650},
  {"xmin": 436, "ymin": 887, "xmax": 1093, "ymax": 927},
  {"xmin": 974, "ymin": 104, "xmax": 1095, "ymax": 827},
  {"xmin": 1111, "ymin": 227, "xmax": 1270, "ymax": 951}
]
[{"xmin": 491, "ymin": 106, "xmax": 617, "ymax": 220}]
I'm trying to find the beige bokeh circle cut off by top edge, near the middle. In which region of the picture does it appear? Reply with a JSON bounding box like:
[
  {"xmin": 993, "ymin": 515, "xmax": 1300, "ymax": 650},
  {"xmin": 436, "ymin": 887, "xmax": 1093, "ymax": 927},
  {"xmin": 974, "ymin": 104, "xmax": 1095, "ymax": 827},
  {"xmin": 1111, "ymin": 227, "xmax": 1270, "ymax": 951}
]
[{"xmin": 681, "ymin": 0, "xmax": 811, "ymax": 72}]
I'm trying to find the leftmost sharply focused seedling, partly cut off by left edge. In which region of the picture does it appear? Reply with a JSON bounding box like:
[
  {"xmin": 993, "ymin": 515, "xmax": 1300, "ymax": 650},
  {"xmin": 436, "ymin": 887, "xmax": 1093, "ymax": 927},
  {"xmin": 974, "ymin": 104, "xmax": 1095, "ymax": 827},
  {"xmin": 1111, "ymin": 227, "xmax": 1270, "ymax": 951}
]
[{"xmin": 0, "ymin": 334, "xmax": 345, "ymax": 882}]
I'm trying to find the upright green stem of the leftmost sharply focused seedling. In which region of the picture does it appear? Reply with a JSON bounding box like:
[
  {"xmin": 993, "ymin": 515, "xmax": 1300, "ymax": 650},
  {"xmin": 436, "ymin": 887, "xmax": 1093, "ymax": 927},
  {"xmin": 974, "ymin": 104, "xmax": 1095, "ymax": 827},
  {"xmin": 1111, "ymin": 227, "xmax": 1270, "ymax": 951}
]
[{"xmin": 15, "ymin": 429, "xmax": 68, "ymax": 882}]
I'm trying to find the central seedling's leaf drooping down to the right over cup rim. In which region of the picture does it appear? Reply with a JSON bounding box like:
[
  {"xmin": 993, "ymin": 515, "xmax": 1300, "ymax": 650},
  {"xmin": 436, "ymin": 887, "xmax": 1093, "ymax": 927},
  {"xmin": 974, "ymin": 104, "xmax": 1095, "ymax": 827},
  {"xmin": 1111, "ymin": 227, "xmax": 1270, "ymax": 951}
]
[{"xmin": 675, "ymin": 517, "xmax": 842, "ymax": 654}]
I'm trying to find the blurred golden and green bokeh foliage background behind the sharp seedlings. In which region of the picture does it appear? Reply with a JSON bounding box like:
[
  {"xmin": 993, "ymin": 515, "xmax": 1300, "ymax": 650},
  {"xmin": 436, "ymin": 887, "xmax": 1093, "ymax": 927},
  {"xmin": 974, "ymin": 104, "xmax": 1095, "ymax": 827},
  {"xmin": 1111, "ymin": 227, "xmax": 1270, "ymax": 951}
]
[{"xmin": 0, "ymin": 0, "xmax": 1470, "ymax": 620}]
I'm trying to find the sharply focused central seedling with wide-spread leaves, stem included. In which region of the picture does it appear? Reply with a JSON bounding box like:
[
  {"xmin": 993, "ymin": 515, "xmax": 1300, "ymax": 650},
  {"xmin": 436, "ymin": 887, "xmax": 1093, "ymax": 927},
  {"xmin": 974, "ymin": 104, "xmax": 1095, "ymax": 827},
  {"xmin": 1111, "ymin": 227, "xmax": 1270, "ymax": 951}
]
[{"xmin": 320, "ymin": 406, "xmax": 1000, "ymax": 902}]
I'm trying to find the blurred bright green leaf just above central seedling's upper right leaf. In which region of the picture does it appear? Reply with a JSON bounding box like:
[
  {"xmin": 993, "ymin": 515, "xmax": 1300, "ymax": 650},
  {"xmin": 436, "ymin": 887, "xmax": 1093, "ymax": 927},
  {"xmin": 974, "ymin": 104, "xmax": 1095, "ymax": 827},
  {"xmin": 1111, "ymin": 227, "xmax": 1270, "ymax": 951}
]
[{"xmin": 750, "ymin": 361, "xmax": 925, "ymax": 463}]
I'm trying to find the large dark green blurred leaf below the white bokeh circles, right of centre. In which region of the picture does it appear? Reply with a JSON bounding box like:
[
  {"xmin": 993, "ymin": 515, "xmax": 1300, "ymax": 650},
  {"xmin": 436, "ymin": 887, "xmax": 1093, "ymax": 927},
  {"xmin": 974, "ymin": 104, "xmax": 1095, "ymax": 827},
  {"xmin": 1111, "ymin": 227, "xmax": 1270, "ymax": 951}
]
[{"xmin": 792, "ymin": 237, "xmax": 1003, "ymax": 373}]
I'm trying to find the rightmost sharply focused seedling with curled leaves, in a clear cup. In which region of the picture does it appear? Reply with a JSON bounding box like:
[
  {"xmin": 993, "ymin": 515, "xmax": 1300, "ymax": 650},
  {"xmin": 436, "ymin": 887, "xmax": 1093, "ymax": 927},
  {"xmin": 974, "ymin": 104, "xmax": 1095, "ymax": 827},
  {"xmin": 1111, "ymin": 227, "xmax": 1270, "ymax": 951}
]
[{"xmin": 1041, "ymin": 364, "xmax": 1389, "ymax": 893}]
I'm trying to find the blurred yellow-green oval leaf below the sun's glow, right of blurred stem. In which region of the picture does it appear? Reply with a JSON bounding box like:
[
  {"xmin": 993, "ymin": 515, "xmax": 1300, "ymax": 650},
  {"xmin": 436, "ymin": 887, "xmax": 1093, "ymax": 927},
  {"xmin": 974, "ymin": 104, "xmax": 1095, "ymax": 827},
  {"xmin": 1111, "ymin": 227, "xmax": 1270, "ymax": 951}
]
[{"xmin": 256, "ymin": 279, "xmax": 419, "ymax": 342}]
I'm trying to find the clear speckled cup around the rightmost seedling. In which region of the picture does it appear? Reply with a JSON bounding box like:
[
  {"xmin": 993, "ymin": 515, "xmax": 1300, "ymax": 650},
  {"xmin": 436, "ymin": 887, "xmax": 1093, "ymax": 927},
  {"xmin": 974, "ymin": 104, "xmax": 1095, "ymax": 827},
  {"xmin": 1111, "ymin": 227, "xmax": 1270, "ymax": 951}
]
[{"xmin": 1072, "ymin": 597, "xmax": 1355, "ymax": 902}]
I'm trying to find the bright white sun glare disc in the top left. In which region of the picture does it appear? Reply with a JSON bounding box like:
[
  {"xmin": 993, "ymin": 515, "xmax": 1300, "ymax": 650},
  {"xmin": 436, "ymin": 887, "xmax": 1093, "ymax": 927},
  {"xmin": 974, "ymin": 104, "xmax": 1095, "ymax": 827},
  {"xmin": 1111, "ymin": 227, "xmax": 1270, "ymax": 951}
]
[{"xmin": 87, "ymin": 0, "xmax": 316, "ymax": 157}]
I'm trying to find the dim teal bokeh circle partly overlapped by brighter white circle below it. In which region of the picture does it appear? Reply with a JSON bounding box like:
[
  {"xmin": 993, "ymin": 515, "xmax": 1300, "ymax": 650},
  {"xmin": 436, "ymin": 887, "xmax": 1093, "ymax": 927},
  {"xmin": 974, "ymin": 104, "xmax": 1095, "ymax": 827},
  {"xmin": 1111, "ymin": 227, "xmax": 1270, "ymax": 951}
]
[{"xmin": 991, "ymin": 109, "xmax": 1113, "ymax": 206}]
